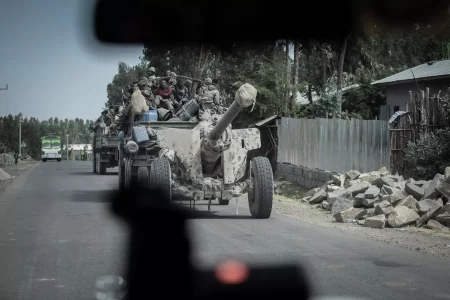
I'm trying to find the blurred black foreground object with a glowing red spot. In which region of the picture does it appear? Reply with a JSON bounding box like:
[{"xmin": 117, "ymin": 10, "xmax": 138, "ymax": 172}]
[{"xmin": 110, "ymin": 185, "xmax": 310, "ymax": 300}]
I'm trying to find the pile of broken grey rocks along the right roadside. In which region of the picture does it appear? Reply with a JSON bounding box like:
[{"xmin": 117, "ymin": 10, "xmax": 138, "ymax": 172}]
[{"xmin": 302, "ymin": 167, "xmax": 450, "ymax": 231}]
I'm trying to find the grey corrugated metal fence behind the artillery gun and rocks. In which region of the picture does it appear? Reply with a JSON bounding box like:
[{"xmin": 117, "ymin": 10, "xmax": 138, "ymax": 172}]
[{"xmin": 278, "ymin": 118, "xmax": 390, "ymax": 173}]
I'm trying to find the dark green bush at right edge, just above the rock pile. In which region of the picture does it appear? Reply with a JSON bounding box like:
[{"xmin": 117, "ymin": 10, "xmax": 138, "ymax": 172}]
[{"xmin": 405, "ymin": 128, "xmax": 450, "ymax": 179}]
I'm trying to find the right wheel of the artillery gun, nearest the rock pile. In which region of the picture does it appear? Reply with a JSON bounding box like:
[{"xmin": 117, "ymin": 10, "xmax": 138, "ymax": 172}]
[{"xmin": 248, "ymin": 156, "xmax": 273, "ymax": 219}]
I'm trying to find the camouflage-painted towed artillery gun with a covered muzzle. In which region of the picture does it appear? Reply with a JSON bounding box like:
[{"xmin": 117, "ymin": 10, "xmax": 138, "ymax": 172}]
[{"xmin": 119, "ymin": 84, "xmax": 273, "ymax": 218}]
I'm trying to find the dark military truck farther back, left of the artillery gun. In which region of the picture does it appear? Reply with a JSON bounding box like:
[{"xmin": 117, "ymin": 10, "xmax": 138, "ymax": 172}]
[{"xmin": 92, "ymin": 124, "xmax": 119, "ymax": 175}]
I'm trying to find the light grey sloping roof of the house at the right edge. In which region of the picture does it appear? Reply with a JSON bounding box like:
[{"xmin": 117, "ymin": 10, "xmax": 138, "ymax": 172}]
[{"xmin": 372, "ymin": 59, "xmax": 450, "ymax": 84}]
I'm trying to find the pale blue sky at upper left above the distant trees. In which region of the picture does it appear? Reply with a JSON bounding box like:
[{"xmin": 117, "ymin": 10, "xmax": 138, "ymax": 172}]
[{"xmin": 0, "ymin": 0, "xmax": 142, "ymax": 120}]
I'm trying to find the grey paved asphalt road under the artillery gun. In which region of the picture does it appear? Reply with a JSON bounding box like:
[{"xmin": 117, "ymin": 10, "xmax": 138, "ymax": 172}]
[{"xmin": 0, "ymin": 162, "xmax": 450, "ymax": 300}]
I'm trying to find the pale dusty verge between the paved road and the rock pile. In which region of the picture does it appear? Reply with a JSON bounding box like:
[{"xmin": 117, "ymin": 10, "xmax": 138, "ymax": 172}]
[{"xmin": 274, "ymin": 181, "xmax": 450, "ymax": 259}]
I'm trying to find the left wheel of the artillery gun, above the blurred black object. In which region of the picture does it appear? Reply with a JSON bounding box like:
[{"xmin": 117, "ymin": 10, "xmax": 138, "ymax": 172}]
[{"xmin": 149, "ymin": 157, "xmax": 172, "ymax": 201}]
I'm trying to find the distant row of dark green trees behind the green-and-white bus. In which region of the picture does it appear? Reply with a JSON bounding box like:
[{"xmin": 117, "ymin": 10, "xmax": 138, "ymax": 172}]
[{"xmin": 0, "ymin": 115, "xmax": 91, "ymax": 159}]
